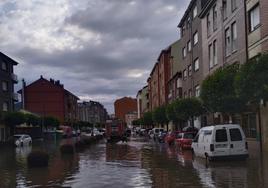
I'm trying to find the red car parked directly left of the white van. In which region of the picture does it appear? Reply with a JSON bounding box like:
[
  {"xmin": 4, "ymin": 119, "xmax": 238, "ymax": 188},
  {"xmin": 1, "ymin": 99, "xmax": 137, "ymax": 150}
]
[{"xmin": 176, "ymin": 132, "xmax": 196, "ymax": 149}]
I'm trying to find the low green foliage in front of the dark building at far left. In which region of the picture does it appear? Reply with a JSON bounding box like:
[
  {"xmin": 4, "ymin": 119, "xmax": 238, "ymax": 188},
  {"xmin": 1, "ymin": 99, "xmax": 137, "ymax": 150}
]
[{"xmin": 4, "ymin": 112, "xmax": 25, "ymax": 127}]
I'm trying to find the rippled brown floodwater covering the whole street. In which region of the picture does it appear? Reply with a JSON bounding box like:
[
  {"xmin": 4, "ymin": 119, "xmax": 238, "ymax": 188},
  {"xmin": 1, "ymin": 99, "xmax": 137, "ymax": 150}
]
[{"xmin": 0, "ymin": 138, "xmax": 268, "ymax": 188}]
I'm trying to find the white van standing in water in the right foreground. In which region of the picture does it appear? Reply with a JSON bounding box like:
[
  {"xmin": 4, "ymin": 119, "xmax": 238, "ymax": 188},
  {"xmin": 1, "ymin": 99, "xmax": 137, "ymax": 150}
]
[{"xmin": 192, "ymin": 124, "xmax": 248, "ymax": 160}]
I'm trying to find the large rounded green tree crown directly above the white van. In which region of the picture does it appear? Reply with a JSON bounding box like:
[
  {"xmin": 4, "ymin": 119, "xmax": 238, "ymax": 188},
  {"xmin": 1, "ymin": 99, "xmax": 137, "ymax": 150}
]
[{"xmin": 200, "ymin": 64, "xmax": 243, "ymax": 113}]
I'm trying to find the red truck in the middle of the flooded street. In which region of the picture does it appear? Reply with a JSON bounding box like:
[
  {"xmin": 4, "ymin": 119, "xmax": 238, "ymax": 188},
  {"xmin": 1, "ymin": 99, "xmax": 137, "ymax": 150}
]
[{"xmin": 105, "ymin": 119, "xmax": 126, "ymax": 142}]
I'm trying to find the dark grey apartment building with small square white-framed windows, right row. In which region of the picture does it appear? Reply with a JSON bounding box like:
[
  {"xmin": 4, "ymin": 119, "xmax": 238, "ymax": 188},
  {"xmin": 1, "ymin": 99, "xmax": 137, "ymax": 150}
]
[{"xmin": 178, "ymin": 0, "xmax": 207, "ymax": 98}]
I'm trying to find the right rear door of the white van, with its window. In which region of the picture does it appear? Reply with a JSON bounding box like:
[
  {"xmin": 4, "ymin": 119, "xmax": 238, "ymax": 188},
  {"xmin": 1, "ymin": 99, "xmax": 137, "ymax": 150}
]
[{"xmin": 228, "ymin": 127, "xmax": 246, "ymax": 155}]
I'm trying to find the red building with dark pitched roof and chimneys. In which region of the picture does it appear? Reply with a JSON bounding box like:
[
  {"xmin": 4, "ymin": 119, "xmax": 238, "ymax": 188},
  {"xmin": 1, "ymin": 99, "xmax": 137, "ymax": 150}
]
[{"xmin": 19, "ymin": 76, "xmax": 79, "ymax": 124}]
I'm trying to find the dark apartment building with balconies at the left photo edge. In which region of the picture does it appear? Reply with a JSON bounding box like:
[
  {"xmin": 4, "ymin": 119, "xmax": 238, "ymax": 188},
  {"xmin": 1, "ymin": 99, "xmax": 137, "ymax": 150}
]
[{"xmin": 0, "ymin": 52, "xmax": 18, "ymax": 142}]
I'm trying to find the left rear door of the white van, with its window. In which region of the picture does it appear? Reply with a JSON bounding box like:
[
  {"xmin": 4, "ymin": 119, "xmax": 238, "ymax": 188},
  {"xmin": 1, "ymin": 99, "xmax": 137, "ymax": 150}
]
[{"xmin": 214, "ymin": 128, "xmax": 229, "ymax": 156}]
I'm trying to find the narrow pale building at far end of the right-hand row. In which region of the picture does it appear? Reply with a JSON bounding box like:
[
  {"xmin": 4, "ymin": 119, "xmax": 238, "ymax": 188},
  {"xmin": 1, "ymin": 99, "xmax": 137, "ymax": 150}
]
[{"xmin": 136, "ymin": 86, "xmax": 149, "ymax": 119}]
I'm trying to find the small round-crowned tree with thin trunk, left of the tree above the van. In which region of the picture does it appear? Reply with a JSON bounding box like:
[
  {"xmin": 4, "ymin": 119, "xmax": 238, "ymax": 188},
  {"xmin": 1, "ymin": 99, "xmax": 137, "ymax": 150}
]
[{"xmin": 174, "ymin": 97, "xmax": 204, "ymax": 126}]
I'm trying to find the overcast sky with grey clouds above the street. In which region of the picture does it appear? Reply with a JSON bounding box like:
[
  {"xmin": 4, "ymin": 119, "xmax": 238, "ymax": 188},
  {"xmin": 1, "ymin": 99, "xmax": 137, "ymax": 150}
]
[{"xmin": 0, "ymin": 0, "xmax": 190, "ymax": 113}]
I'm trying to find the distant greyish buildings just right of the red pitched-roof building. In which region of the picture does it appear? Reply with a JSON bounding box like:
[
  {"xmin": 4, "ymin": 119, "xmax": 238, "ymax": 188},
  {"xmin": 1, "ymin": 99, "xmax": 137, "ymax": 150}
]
[{"xmin": 77, "ymin": 101, "xmax": 108, "ymax": 124}]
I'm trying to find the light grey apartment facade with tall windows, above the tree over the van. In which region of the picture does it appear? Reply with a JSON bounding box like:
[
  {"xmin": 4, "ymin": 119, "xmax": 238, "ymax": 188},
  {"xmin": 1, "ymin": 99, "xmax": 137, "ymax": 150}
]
[{"xmin": 200, "ymin": 0, "xmax": 247, "ymax": 77}]
